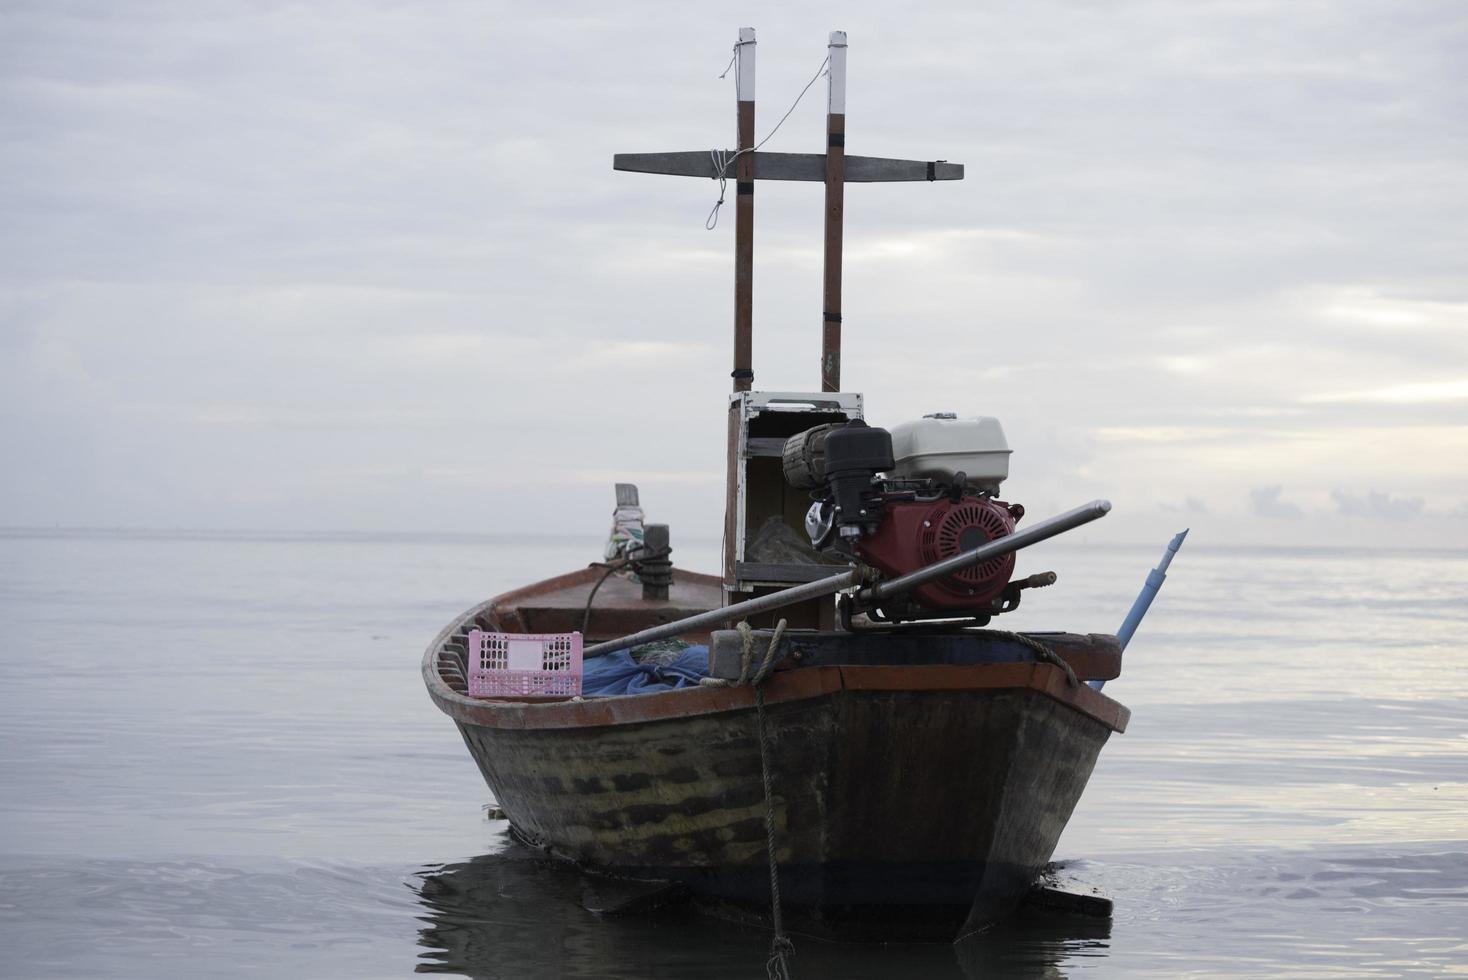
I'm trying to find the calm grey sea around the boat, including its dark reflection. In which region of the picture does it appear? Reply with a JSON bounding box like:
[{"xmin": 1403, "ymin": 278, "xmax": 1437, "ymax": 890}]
[{"xmin": 0, "ymin": 531, "xmax": 1468, "ymax": 980}]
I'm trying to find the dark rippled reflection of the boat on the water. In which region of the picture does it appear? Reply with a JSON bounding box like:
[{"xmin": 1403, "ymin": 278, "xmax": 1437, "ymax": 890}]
[{"xmin": 411, "ymin": 844, "xmax": 1111, "ymax": 980}]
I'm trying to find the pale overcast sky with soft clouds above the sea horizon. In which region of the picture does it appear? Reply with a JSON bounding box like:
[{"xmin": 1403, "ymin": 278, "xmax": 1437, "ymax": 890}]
[{"xmin": 0, "ymin": 0, "xmax": 1468, "ymax": 547}]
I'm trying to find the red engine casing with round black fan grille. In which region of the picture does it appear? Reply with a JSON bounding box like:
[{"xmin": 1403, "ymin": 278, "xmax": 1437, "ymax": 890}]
[{"xmin": 856, "ymin": 494, "xmax": 1025, "ymax": 610}]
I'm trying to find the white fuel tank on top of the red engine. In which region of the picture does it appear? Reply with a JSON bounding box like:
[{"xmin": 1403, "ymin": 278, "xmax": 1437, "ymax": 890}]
[{"xmin": 891, "ymin": 415, "xmax": 1011, "ymax": 493}]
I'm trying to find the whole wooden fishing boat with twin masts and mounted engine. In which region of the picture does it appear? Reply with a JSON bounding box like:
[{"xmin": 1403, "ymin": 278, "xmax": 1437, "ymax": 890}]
[{"xmin": 423, "ymin": 29, "xmax": 1129, "ymax": 940}]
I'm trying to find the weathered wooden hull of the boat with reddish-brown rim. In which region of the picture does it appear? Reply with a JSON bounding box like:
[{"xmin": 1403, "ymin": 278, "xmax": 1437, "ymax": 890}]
[{"xmin": 424, "ymin": 566, "xmax": 1127, "ymax": 940}]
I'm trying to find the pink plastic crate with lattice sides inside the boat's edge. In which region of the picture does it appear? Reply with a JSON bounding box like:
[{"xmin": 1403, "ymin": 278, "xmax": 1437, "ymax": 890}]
[{"xmin": 468, "ymin": 629, "xmax": 581, "ymax": 697}]
